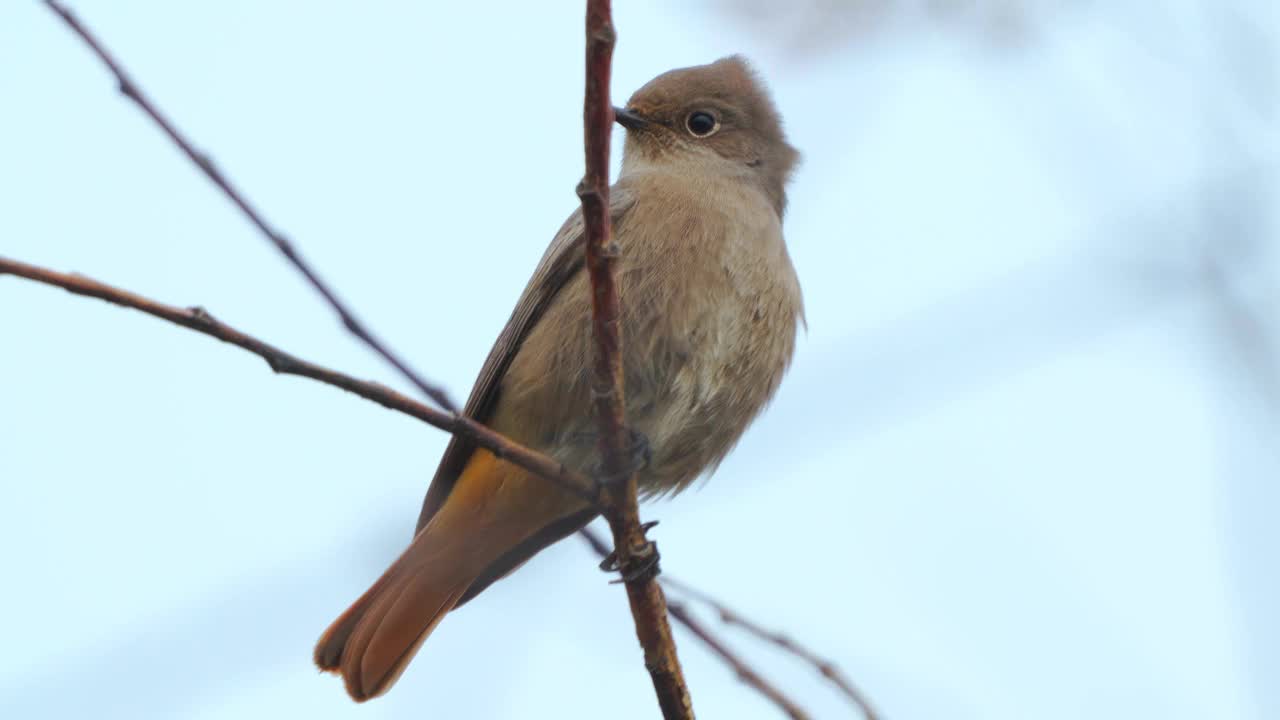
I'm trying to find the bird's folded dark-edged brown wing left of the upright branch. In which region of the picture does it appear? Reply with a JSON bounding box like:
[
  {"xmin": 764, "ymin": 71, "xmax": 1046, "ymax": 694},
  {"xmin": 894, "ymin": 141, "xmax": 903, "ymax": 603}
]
[{"xmin": 415, "ymin": 184, "xmax": 635, "ymax": 534}]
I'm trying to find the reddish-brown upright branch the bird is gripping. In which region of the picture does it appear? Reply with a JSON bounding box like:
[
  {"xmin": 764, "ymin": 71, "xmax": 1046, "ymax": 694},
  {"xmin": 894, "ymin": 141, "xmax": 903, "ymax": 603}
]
[{"xmin": 577, "ymin": 0, "xmax": 694, "ymax": 720}]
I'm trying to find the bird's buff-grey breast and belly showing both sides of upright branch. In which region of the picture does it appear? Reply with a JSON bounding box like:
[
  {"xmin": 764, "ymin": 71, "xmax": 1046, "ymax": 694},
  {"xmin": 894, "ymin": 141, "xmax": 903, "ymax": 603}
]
[{"xmin": 499, "ymin": 170, "xmax": 800, "ymax": 493}]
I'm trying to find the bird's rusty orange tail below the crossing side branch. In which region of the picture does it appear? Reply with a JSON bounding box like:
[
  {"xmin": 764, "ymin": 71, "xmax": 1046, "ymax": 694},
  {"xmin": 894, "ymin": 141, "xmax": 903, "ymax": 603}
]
[{"xmin": 315, "ymin": 450, "xmax": 580, "ymax": 702}]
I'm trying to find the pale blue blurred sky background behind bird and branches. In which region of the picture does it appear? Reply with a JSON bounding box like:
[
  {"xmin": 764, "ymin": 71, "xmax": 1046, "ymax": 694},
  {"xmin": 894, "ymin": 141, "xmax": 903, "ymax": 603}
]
[{"xmin": 0, "ymin": 0, "xmax": 1280, "ymax": 720}]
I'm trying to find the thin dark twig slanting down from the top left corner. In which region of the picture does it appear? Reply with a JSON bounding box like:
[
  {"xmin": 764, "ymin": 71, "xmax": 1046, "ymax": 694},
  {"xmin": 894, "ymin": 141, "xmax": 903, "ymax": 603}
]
[{"xmin": 45, "ymin": 0, "xmax": 458, "ymax": 413}]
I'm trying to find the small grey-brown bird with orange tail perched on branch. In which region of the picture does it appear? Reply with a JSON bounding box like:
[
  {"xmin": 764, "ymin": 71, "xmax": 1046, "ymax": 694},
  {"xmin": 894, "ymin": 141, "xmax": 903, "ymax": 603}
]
[{"xmin": 315, "ymin": 56, "xmax": 803, "ymax": 701}]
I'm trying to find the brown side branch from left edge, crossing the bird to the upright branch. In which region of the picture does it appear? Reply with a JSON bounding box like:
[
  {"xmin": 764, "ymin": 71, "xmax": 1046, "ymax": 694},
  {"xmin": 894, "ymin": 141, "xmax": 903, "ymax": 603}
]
[{"xmin": 0, "ymin": 256, "xmax": 600, "ymax": 505}]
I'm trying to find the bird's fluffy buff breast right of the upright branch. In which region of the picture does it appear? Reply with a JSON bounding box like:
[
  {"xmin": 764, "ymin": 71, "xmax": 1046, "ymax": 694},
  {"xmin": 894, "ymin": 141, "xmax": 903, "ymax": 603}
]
[{"xmin": 620, "ymin": 172, "xmax": 801, "ymax": 492}]
